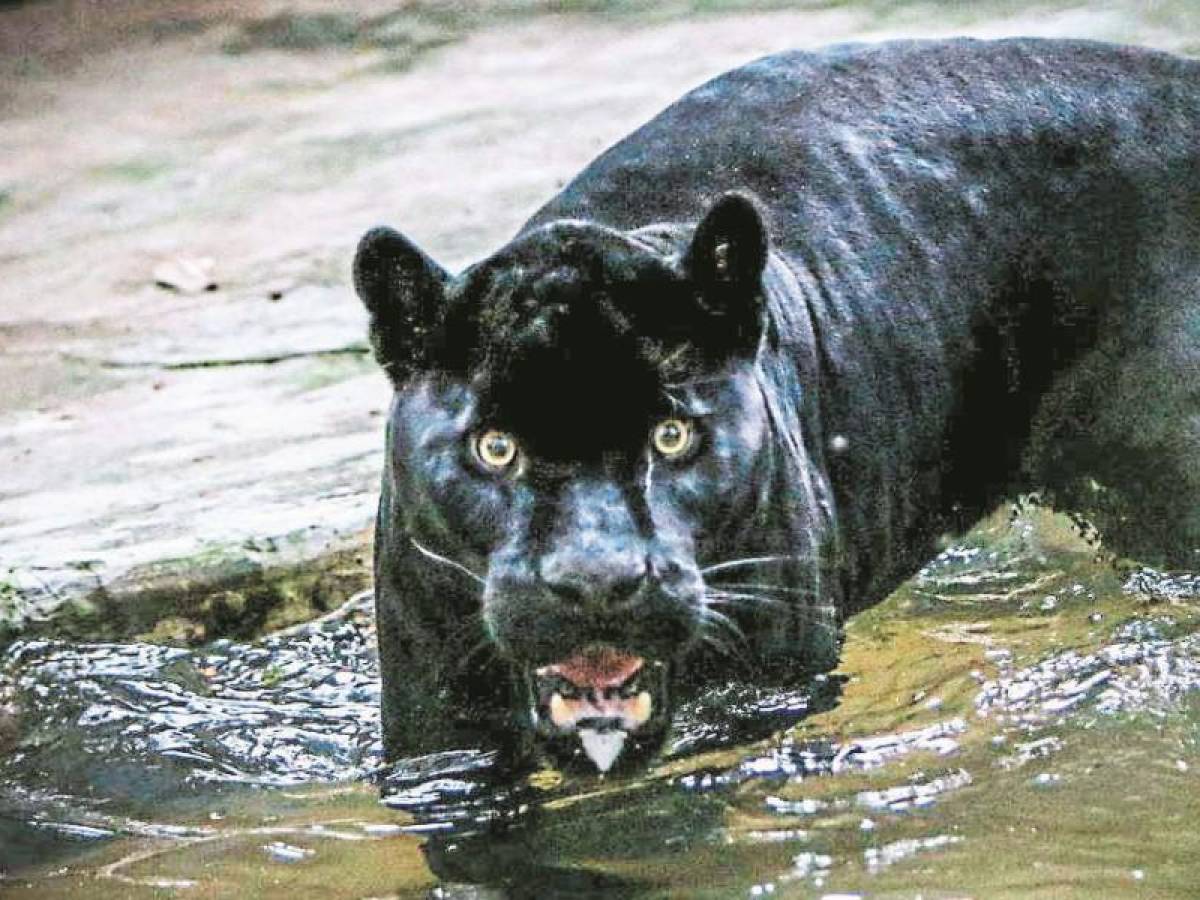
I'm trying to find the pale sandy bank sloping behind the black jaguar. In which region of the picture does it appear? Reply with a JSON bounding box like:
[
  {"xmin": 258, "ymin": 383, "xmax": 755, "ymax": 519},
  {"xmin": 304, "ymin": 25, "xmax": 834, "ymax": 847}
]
[{"xmin": 0, "ymin": 0, "xmax": 1200, "ymax": 643}]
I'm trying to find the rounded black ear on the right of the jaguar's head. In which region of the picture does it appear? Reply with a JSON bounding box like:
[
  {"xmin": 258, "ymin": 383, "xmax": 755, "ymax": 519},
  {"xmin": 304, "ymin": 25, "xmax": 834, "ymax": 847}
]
[{"xmin": 683, "ymin": 192, "xmax": 767, "ymax": 360}]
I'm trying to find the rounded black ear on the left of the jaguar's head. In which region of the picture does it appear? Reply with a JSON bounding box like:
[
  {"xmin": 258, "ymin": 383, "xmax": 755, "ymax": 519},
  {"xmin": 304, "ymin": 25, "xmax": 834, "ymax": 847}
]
[{"xmin": 354, "ymin": 228, "xmax": 450, "ymax": 386}]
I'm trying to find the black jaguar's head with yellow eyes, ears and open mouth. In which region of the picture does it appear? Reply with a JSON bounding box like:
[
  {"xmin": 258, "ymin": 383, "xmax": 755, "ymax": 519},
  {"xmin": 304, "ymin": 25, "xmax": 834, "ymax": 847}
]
[{"xmin": 355, "ymin": 194, "xmax": 816, "ymax": 772}]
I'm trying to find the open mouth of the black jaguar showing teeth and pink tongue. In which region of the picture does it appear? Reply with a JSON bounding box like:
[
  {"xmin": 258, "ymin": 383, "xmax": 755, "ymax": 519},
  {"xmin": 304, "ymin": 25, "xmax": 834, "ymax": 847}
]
[{"xmin": 533, "ymin": 644, "xmax": 667, "ymax": 774}]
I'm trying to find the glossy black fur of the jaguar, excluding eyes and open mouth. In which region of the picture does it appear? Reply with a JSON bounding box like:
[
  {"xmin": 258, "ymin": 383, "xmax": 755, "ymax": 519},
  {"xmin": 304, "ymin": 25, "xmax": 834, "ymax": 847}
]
[{"xmin": 355, "ymin": 40, "xmax": 1200, "ymax": 755}]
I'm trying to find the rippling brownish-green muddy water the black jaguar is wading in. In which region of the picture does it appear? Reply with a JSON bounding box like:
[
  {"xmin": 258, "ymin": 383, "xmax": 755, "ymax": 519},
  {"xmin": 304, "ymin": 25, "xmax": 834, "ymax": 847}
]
[{"xmin": 0, "ymin": 515, "xmax": 1200, "ymax": 898}]
